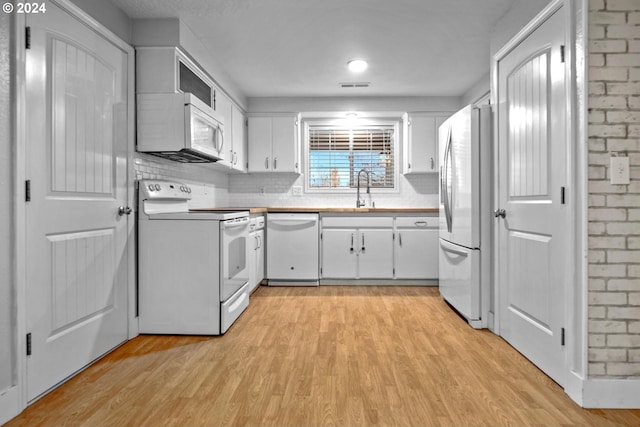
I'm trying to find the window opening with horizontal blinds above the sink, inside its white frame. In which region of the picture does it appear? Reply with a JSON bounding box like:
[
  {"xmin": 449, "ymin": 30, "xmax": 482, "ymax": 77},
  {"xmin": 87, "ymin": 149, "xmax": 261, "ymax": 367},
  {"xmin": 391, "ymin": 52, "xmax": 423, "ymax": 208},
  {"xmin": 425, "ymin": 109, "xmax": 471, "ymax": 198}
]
[{"xmin": 308, "ymin": 126, "xmax": 395, "ymax": 189}]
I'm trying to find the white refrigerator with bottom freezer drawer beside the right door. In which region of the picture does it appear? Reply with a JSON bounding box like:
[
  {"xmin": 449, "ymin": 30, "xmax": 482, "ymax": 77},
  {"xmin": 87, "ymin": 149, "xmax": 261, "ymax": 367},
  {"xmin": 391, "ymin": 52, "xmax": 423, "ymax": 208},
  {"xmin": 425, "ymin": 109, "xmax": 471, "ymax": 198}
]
[{"xmin": 438, "ymin": 105, "xmax": 492, "ymax": 328}]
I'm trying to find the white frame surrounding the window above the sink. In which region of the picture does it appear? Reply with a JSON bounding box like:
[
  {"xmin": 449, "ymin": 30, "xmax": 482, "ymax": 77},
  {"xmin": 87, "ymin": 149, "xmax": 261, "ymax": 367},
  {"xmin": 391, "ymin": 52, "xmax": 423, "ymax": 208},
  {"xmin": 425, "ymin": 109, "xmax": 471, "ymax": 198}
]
[{"xmin": 302, "ymin": 118, "xmax": 402, "ymax": 194}]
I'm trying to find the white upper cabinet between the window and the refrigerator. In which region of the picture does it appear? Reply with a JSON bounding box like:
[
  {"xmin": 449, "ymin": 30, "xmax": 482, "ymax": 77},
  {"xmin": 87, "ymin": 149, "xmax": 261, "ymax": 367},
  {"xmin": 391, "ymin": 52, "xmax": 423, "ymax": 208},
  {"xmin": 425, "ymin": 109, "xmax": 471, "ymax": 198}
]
[{"xmin": 402, "ymin": 113, "xmax": 448, "ymax": 174}]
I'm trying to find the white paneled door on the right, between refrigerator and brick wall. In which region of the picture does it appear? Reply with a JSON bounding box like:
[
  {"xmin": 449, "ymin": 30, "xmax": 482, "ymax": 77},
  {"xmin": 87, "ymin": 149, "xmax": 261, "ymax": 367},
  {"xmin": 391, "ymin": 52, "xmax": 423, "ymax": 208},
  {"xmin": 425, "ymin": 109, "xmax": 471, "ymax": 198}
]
[{"xmin": 496, "ymin": 8, "xmax": 571, "ymax": 385}]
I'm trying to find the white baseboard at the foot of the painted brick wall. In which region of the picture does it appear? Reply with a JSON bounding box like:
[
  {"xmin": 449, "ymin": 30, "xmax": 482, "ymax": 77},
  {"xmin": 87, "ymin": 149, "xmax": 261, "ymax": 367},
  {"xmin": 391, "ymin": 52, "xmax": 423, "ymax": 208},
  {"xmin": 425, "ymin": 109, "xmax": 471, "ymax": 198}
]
[{"xmin": 565, "ymin": 375, "xmax": 640, "ymax": 409}]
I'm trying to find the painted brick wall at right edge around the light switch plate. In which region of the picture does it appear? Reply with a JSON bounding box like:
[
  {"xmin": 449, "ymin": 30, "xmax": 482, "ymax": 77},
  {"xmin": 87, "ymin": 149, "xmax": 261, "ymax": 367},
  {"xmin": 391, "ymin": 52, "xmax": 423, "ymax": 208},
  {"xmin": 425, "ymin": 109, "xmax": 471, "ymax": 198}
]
[{"xmin": 588, "ymin": 0, "xmax": 640, "ymax": 378}]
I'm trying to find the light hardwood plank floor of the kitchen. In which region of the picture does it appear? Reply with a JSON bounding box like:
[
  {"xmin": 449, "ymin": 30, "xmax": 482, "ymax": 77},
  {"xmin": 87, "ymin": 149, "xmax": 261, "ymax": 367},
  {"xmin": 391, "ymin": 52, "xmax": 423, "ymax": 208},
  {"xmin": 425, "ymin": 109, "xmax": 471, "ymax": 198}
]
[{"xmin": 7, "ymin": 286, "xmax": 640, "ymax": 427}]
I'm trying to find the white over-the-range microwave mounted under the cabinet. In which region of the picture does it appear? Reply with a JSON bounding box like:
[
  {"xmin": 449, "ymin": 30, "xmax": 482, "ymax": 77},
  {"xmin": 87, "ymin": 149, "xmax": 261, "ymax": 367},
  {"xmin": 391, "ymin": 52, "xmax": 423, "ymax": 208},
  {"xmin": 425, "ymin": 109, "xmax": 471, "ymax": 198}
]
[{"xmin": 136, "ymin": 93, "xmax": 224, "ymax": 163}]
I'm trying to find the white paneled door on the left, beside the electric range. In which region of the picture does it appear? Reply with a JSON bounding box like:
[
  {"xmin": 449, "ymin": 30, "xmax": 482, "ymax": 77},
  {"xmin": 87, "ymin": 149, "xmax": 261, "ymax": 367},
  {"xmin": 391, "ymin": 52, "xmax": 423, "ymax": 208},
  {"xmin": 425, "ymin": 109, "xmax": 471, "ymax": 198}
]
[{"xmin": 25, "ymin": 2, "xmax": 132, "ymax": 400}]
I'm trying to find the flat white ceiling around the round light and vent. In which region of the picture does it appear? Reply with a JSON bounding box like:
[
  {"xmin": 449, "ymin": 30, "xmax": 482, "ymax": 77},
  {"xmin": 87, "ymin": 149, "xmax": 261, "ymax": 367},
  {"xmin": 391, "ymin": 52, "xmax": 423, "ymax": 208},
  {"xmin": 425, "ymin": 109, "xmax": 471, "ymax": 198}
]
[{"xmin": 111, "ymin": 0, "xmax": 514, "ymax": 97}]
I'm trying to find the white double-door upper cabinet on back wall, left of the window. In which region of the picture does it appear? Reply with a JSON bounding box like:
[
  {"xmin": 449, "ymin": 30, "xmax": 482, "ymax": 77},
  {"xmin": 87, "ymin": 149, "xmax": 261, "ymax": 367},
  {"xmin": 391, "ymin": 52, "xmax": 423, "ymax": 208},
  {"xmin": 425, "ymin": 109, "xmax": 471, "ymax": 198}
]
[{"xmin": 248, "ymin": 114, "xmax": 300, "ymax": 173}]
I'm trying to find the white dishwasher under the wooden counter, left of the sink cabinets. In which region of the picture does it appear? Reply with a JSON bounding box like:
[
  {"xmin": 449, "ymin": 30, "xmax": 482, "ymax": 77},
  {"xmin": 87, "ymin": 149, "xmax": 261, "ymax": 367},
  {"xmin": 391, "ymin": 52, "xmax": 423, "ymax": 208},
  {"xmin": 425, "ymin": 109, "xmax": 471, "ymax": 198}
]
[{"xmin": 267, "ymin": 213, "xmax": 320, "ymax": 286}]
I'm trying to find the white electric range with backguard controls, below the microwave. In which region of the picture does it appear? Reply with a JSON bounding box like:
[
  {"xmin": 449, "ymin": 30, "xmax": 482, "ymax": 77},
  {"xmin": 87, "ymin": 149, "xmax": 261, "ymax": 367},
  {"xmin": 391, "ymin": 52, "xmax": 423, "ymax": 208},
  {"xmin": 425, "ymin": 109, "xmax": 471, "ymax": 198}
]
[{"xmin": 138, "ymin": 180, "xmax": 250, "ymax": 335}]
